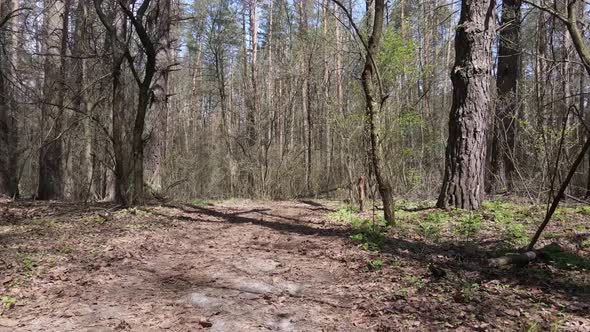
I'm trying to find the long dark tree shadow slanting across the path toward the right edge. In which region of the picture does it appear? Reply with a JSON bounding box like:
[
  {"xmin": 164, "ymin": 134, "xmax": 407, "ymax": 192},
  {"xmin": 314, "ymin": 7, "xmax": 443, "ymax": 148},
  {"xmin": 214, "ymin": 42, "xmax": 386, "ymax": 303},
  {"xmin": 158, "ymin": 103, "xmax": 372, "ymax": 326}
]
[{"xmin": 165, "ymin": 205, "xmax": 590, "ymax": 316}]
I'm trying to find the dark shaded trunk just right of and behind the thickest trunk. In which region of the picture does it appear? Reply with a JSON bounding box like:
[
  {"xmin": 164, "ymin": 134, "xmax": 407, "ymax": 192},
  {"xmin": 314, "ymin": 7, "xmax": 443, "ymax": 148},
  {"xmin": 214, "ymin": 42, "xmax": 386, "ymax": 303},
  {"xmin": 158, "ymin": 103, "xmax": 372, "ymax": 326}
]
[{"xmin": 488, "ymin": 0, "xmax": 521, "ymax": 192}]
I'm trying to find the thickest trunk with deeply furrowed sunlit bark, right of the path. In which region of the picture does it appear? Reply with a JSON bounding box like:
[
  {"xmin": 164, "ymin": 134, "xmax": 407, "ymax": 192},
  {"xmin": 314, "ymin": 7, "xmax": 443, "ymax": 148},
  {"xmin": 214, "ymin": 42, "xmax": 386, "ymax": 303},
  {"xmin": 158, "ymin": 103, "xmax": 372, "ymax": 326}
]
[{"xmin": 437, "ymin": 0, "xmax": 496, "ymax": 210}]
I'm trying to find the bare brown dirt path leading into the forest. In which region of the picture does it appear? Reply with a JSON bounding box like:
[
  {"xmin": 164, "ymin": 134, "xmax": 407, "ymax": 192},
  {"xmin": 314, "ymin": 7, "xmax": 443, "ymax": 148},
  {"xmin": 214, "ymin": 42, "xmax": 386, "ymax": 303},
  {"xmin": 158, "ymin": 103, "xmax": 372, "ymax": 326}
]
[{"xmin": 0, "ymin": 203, "xmax": 384, "ymax": 331}]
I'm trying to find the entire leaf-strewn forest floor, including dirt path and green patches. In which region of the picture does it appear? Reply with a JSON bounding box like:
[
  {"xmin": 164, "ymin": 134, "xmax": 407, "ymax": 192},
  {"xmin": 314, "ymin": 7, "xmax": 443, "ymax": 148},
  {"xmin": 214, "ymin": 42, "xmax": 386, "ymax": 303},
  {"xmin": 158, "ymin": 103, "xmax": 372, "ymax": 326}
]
[{"xmin": 0, "ymin": 200, "xmax": 590, "ymax": 331}]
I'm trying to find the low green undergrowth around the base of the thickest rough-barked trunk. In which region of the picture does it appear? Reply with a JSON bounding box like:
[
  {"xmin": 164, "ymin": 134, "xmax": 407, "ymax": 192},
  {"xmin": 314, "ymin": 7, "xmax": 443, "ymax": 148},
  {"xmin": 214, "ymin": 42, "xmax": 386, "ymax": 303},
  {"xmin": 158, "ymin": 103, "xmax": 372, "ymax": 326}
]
[{"xmin": 328, "ymin": 201, "xmax": 564, "ymax": 250}]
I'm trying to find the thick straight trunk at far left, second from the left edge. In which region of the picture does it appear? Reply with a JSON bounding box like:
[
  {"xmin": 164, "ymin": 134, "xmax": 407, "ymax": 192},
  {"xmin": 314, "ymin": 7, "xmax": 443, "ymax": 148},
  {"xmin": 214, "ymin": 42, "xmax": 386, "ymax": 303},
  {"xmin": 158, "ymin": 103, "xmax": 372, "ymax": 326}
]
[{"xmin": 37, "ymin": 0, "xmax": 70, "ymax": 200}]
